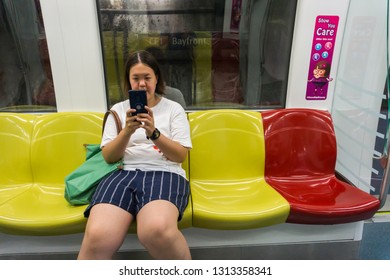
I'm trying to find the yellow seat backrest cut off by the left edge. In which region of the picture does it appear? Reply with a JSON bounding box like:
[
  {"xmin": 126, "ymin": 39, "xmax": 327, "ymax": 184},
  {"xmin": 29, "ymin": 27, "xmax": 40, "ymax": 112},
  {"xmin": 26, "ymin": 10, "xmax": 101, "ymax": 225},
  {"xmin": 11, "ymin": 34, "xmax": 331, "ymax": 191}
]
[{"xmin": 0, "ymin": 113, "xmax": 36, "ymax": 189}]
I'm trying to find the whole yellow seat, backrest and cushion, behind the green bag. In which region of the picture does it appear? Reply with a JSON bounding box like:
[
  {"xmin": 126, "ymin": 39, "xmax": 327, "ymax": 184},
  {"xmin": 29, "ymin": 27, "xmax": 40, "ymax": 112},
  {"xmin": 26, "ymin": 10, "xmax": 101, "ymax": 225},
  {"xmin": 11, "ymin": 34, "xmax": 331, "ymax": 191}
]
[{"xmin": 0, "ymin": 113, "xmax": 103, "ymax": 235}]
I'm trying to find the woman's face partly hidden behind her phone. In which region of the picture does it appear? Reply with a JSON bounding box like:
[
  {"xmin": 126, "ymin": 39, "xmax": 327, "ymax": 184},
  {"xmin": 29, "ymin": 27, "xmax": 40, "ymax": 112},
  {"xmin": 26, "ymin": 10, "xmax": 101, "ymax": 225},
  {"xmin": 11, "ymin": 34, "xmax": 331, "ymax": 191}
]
[{"xmin": 129, "ymin": 63, "xmax": 158, "ymax": 100}]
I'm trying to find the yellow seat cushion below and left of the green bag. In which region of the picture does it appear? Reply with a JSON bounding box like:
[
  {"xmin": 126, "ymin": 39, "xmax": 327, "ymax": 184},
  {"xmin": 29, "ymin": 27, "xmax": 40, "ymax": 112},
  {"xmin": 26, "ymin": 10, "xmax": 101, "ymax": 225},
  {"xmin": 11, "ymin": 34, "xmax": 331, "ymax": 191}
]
[{"xmin": 0, "ymin": 184, "xmax": 87, "ymax": 235}]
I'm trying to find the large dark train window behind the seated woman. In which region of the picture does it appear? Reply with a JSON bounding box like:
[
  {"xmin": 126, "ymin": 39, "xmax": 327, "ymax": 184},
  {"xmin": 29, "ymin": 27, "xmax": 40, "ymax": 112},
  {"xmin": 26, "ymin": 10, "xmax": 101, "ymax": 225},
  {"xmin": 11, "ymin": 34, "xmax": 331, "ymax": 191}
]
[{"xmin": 97, "ymin": 0, "xmax": 297, "ymax": 110}]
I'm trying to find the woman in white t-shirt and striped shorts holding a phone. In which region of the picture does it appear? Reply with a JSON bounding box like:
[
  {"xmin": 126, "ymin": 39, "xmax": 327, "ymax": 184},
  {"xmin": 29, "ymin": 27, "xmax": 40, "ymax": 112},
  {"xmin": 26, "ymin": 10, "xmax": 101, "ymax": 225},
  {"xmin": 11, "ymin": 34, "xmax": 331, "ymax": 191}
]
[{"xmin": 78, "ymin": 51, "xmax": 192, "ymax": 259}]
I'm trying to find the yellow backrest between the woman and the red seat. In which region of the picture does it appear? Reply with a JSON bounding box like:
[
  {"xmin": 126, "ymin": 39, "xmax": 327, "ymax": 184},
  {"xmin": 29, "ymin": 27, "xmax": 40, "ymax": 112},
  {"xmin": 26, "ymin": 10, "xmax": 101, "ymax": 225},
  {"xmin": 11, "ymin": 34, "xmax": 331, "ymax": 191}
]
[{"xmin": 189, "ymin": 109, "xmax": 264, "ymax": 181}]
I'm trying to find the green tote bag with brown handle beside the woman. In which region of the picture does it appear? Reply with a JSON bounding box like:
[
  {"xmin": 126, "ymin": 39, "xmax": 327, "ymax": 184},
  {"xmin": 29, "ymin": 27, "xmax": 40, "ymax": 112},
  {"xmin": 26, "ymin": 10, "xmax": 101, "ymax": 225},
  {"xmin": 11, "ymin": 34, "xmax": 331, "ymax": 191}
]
[{"xmin": 64, "ymin": 110, "xmax": 122, "ymax": 205}]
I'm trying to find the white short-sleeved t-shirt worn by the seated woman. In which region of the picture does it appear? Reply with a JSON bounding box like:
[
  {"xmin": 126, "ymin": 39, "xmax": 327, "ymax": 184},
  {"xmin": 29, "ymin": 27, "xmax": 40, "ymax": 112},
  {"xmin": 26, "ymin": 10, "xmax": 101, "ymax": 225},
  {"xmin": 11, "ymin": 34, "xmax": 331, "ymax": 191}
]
[{"xmin": 101, "ymin": 97, "xmax": 192, "ymax": 177}]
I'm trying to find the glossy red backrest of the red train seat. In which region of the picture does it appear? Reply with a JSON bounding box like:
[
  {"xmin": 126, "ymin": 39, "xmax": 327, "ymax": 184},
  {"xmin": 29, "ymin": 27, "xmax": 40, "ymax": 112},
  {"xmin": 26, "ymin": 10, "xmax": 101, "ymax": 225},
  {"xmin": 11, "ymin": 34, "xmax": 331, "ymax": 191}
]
[{"xmin": 262, "ymin": 108, "xmax": 337, "ymax": 177}]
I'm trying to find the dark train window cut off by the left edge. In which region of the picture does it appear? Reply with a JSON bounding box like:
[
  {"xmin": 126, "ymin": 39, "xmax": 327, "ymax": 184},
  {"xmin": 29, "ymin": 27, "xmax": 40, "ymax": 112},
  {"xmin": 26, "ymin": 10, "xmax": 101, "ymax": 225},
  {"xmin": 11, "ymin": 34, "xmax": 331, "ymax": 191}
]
[{"xmin": 0, "ymin": 0, "xmax": 56, "ymax": 111}]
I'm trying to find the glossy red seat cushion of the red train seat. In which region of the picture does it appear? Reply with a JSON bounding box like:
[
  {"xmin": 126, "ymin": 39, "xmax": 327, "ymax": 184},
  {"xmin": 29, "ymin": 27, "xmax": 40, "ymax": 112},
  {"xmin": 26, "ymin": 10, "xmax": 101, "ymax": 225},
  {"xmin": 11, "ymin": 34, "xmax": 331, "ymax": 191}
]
[{"xmin": 267, "ymin": 175, "xmax": 380, "ymax": 224}]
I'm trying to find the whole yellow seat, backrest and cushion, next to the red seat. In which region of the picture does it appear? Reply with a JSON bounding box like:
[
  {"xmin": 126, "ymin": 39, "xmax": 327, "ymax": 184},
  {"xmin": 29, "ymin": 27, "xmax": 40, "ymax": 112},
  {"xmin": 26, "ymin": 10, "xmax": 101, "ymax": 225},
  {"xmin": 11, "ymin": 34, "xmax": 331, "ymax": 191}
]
[{"xmin": 189, "ymin": 109, "xmax": 290, "ymax": 229}]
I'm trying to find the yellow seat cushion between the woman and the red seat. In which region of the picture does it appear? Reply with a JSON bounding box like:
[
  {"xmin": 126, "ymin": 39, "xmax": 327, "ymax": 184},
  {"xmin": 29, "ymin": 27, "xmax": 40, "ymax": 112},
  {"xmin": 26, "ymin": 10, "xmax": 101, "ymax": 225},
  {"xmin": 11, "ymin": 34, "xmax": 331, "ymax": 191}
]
[{"xmin": 191, "ymin": 178, "xmax": 290, "ymax": 230}]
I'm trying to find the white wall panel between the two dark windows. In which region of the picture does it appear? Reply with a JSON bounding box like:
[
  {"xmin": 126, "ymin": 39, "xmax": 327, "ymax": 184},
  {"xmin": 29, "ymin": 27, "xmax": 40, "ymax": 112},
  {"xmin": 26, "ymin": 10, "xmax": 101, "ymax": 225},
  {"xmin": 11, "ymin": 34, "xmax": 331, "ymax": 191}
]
[{"xmin": 41, "ymin": 0, "xmax": 107, "ymax": 112}]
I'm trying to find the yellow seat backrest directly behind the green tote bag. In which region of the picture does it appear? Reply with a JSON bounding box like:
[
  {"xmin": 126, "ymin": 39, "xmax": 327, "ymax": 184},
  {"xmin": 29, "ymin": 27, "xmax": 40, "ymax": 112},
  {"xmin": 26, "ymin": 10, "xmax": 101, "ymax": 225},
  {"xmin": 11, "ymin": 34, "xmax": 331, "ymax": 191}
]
[{"xmin": 31, "ymin": 112, "xmax": 104, "ymax": 184}]
